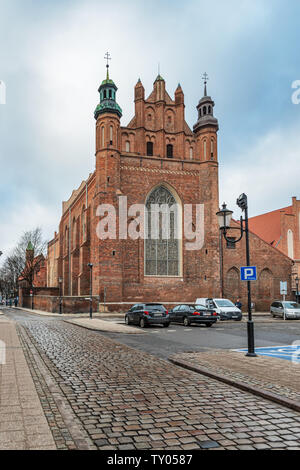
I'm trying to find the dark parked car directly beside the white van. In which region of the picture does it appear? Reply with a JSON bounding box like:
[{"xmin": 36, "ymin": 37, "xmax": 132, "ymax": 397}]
[{"xmin": 169, "ymin": 305, "xmax": 219, "ymax": 327}]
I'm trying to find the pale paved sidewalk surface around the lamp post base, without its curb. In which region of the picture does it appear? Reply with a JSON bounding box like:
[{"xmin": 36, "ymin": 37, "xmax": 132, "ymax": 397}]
[{"xmin": 172, "ymin": 351, "xmax": 300, "ymax": 403}]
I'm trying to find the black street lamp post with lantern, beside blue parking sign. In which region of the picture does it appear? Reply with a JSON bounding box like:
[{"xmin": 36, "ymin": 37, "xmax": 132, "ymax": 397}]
[{"xmin": 216, "ymin": 194, "xmax": 257, "ymax": 357}]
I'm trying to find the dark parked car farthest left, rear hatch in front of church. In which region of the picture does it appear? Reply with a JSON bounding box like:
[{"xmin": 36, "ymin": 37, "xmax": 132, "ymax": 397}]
[{"xmin": 125, "ymin": 303, "xmax": 170, "ymax": 328}]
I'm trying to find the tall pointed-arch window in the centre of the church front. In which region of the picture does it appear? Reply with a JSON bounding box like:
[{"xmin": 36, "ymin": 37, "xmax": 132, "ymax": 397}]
[{"xmin": 145, "ymin": 186, "xmax": 180, "ymax": 276}]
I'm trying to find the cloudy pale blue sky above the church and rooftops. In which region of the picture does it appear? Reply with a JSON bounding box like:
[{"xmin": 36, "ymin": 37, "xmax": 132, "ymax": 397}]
[{"xmin": 0, "ymin": 0, "xmax": 300, "ymax": 259}]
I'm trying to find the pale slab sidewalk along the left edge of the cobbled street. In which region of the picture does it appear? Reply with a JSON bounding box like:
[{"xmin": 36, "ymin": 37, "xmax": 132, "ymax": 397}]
[{"xmin": 0, "ymin": 318, "xmax": 56, "ymax": 450}]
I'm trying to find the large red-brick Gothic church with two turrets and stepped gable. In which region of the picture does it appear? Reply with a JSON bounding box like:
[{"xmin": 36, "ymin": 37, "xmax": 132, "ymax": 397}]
[{"xmin": 35, "ymin": 62, "xmax": 293, "ymax": 311}]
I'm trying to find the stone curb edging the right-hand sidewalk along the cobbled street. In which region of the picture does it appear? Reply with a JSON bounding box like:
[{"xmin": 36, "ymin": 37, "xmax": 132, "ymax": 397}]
[{"xmin": 169, "ymin": 357, "xmax": 300, "ymax": 412}]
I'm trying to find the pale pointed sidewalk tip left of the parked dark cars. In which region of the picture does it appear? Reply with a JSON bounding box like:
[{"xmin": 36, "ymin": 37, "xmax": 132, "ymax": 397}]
[{"xmin": 63, "ymin": 318, "xmax": 146, "ymax": 335}]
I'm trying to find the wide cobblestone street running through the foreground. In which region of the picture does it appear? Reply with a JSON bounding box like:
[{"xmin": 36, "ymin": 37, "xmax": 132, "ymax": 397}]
[{"xmin": 9, "ymin": 318, "xmax": 300, "ymax": 450}]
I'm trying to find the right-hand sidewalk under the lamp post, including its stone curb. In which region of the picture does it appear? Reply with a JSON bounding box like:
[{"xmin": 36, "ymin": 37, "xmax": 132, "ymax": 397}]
[{"xmin": 170, "ymin": 350, "xmax": 300, "ymax": 411}]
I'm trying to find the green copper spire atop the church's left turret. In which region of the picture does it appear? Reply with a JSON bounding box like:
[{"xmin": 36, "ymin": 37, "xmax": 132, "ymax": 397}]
[{"xmin": 94, "ymin": 52, "xmax": 122, "ymax": 119}]
